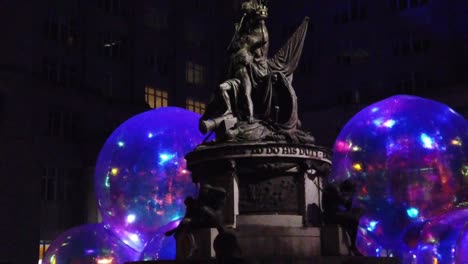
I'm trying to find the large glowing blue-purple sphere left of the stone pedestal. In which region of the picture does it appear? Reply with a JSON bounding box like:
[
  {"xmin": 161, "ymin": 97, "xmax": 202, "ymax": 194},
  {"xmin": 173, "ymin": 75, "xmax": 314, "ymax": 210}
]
[{"xmin": 95, "ymin": 107, "xmax": 204, "ymax": 252}]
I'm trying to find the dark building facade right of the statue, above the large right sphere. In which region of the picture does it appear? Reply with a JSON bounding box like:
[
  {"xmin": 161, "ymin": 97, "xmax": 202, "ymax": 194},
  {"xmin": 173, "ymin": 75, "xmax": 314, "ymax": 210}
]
[{"xmin": 270, "ymin": 0, "xmax": 468, "ymax": 147}]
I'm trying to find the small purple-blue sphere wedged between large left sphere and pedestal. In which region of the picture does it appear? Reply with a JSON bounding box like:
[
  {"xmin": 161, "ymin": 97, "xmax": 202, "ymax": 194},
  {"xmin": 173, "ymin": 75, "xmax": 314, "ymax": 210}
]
[{"xmin": 140, "ymin": 219, "xmax": 180, "ymax": 261}]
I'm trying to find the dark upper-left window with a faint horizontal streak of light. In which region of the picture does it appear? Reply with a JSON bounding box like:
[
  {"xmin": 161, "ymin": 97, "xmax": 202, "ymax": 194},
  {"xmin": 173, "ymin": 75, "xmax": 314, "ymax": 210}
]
[{"xmin": 99, "ymin": 32, "xmax": 127, "ymax": 59}]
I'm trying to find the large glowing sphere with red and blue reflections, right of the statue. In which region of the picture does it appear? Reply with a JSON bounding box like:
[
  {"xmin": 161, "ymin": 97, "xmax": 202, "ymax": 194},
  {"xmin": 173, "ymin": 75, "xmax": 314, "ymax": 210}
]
[{"xmin": 329, "ymin": 95, "xmax": 468, "ymax": 253}]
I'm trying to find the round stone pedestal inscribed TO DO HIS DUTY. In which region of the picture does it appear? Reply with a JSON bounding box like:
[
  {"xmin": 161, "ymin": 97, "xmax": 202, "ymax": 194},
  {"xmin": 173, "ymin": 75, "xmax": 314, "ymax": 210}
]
[{"xmin": 177, "ymin": 142, "xmax": 331, "ymax": 260}]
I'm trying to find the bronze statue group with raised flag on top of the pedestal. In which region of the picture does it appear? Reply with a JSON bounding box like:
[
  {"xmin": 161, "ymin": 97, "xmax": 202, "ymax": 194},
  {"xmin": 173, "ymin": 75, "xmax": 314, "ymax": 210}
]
[{"xmin": 200, "ymin": 0, "xmax": 314, "ymax": 143}]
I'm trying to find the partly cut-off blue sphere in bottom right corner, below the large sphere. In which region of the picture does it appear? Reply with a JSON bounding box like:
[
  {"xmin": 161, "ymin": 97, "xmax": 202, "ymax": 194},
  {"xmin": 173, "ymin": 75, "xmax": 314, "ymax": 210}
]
[{"xmin": 412, "ymin": 208, "xmax": 468, "ymax": 264}]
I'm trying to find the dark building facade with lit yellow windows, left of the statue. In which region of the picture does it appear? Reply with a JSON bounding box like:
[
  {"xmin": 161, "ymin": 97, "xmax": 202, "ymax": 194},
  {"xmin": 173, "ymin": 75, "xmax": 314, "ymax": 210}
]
[{"xmin": 0, "ymin": 0, "xmax": 229, "ymax": 263}]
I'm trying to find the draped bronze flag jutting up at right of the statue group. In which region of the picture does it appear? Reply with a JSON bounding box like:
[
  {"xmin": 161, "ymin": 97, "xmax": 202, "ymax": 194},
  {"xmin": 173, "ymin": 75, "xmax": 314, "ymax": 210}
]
[{"xmin": 268, "ymin": 17, "xmax": 309, "ymax": 79}]
